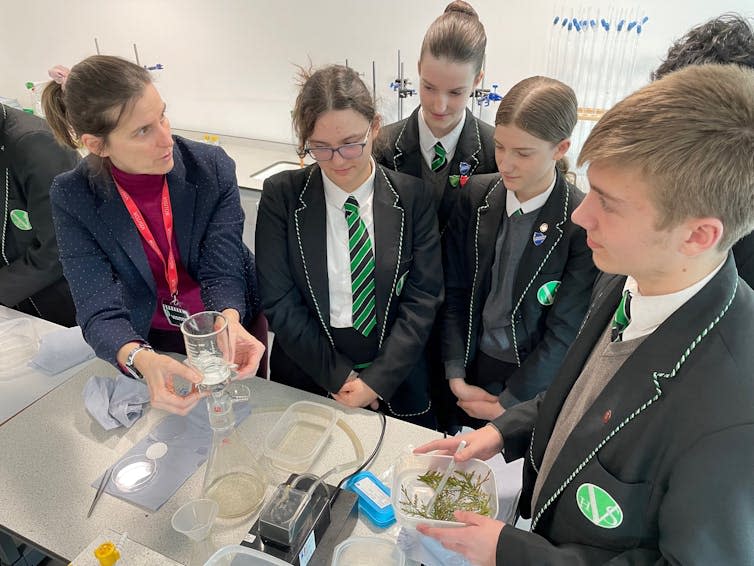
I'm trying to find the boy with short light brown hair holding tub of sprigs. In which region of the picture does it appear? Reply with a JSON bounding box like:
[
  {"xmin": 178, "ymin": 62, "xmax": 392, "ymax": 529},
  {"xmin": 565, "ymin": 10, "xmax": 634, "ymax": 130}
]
[{"xmin": 419, "ymin": 65, "xmax": 754, "ymax": 566}]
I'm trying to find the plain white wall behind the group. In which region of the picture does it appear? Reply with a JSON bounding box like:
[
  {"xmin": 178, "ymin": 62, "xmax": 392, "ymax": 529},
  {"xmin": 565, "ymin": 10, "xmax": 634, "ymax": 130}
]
[{"xmin": 0, "ymin": 0, "xmax": 754, "ymax": 142}]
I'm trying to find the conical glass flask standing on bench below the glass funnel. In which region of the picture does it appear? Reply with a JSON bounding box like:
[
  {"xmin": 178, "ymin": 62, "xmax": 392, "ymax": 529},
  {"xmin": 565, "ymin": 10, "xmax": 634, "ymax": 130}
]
[{"xmin": 202, "ymin": 387, "xmax": 267, "ymax": 519}]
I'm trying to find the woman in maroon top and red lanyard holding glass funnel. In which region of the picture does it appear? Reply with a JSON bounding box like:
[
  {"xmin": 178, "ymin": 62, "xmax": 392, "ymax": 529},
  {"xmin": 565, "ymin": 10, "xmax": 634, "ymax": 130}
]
[{"xmin": 43, "ymin": 56, "xmax": 264, "ymax": 414}]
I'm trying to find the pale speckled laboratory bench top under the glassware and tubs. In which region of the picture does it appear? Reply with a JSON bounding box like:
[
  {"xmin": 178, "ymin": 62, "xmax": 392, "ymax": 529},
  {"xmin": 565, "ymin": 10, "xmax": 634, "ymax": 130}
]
[{"xmin": 0, "ymin": 360, "xmax": 439, "ymax": 563}]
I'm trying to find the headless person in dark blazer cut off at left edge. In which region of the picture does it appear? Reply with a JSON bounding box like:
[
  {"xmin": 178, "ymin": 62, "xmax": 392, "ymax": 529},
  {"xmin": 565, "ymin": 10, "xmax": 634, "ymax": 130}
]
[{"xmin": 0, "ymin": 100, "xmax": 78, "ymax": 326}]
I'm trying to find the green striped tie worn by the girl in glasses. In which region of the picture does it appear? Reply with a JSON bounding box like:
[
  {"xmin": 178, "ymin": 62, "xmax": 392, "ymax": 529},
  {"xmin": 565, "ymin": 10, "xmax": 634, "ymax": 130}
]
[{"xmin": 344, "ymin": 197, "xmax": 377, "ymax": 336}]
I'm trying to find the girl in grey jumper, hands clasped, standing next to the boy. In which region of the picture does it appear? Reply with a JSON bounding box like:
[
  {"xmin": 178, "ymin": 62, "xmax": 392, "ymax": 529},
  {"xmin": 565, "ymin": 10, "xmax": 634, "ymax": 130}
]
[{"xmin": 443, "ymin": 77, "xmax": 597, "ymax": 419}]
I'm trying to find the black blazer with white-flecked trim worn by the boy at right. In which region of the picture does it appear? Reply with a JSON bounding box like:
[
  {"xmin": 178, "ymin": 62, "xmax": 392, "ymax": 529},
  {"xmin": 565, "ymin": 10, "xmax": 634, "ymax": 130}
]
[{"xmin": 493, "ymin": 255, "xmax": 754, "ymax": 566}]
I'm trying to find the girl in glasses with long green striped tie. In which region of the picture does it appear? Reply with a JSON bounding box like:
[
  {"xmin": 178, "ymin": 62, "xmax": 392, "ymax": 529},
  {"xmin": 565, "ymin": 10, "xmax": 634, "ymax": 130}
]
[{"xmin": 256, "ymin": 66, "xmax": 443, "ymax": 426}]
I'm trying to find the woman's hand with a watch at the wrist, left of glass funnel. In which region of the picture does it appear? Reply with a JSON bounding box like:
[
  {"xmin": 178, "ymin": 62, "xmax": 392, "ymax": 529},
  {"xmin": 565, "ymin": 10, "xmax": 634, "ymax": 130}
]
[{"xmin": 134, "ymin": 350, "xmax": 207, "ymax": 415}]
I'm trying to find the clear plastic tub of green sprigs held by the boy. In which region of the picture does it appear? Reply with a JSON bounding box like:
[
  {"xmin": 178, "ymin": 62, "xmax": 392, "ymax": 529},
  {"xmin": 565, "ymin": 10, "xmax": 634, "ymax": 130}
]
[{"xmin": 391, "ymin": 453, "xmax": 498, "ymax": 529}]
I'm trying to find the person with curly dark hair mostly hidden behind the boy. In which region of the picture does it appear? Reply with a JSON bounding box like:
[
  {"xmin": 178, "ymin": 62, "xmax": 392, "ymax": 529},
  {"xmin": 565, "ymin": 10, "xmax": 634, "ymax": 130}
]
[{"xmin": 652, "ymin": 14, "xmax": 754, "ymax": 288}]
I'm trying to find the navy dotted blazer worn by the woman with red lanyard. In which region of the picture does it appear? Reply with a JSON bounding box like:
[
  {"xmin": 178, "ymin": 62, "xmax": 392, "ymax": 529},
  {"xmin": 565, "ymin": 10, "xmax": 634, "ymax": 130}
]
[{"xmin": 50, "ymin": 136, "xmax": 259, "ymax": 366}]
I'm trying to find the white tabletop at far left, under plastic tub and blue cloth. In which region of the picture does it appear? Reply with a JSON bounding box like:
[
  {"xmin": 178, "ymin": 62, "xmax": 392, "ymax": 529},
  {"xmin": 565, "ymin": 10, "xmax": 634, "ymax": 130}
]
[{"xmin": 0, "ymin": 305, "xmax": 92, "ymax": 426}]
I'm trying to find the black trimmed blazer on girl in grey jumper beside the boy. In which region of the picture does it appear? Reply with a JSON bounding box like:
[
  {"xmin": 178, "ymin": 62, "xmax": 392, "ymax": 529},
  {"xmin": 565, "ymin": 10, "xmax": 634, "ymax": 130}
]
[{"xmin": 442, "ymin": 172, "xmax": 597, "ymax": 401}]
